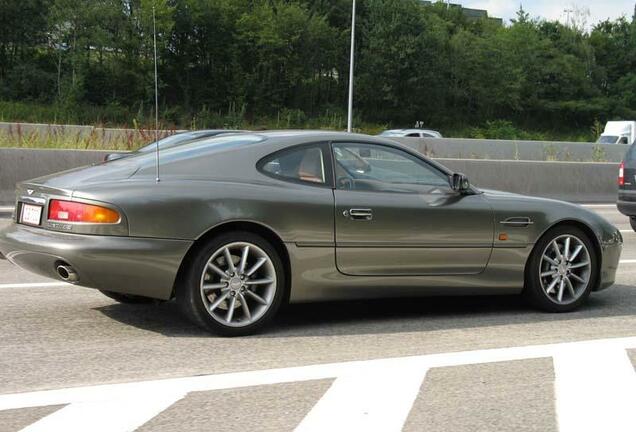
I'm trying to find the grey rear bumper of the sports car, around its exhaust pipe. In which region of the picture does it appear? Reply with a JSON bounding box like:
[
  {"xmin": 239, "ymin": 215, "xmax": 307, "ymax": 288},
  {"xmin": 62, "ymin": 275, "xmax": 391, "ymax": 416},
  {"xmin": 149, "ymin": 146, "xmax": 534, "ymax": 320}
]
[{"xmin": 0, "ymin": 223, "xmax": 192, "ymax": 300}]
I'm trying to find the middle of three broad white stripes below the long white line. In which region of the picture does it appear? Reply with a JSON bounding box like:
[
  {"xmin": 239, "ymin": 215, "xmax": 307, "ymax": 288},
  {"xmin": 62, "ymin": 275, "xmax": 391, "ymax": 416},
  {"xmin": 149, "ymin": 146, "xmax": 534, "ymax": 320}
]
[{"xmin": 296, "ymin": 366, "xmax": 428, "ymax": 432}]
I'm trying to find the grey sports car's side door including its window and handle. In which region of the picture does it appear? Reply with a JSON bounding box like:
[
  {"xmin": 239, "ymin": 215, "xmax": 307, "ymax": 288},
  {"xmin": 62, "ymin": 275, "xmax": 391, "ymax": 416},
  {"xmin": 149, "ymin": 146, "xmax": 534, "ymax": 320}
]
[{"xmin": 332, "ymin": 142, "xmax": 494, "ymax": 276}]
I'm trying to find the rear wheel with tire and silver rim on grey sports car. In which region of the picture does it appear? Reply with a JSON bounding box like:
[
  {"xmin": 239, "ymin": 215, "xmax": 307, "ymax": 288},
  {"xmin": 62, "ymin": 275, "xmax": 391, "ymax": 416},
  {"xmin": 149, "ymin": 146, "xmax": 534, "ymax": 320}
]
[{"xmin": 177, "ymin": 232, "xmax": 285, "ymax": 336}]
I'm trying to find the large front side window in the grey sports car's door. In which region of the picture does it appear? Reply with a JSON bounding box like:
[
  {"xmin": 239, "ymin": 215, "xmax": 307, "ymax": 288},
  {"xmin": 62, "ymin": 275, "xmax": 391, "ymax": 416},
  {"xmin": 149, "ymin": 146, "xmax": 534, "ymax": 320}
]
[{"xmin": 333, "ymin": 143, "xmax": 450, "ymax": 193}]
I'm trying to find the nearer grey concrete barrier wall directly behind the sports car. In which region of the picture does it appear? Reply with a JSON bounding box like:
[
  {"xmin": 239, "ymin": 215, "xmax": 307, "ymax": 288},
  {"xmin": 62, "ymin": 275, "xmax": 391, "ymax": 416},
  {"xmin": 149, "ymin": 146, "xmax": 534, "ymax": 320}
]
[{"xmin": 0, "ymin": 148, "xmax": 618, "ymax": 205}]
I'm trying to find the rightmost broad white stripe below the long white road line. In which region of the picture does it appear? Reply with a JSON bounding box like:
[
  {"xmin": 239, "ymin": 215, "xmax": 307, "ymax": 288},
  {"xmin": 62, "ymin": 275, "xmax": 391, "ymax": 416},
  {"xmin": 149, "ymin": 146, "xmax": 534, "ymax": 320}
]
[{"xmin": 554, "ymin": 346, "xmax": 636, "ymax": 432}]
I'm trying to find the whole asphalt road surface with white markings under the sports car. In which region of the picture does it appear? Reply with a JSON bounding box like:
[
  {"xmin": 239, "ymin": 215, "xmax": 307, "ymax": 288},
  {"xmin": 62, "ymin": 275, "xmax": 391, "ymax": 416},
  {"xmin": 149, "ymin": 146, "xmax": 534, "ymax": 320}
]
[{"xmin": 0, "ymin": 206, "xmax": 636, "ymax": 432}]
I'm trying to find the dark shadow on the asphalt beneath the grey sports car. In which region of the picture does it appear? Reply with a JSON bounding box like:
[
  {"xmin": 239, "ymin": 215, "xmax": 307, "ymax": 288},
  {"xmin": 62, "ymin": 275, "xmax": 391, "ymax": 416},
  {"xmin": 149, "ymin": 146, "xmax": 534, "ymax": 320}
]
[{"xmin": 96, "ymin": 285, "xmax": 636, "ymax": 338}]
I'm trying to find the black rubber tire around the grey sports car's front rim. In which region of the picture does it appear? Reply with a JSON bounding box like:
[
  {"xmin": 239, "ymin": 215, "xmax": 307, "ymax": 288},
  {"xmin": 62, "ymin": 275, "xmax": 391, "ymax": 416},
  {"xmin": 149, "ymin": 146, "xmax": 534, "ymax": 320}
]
[{"xmin": 523, "ymin": 225, "xmax": 599, "ymax": 313}]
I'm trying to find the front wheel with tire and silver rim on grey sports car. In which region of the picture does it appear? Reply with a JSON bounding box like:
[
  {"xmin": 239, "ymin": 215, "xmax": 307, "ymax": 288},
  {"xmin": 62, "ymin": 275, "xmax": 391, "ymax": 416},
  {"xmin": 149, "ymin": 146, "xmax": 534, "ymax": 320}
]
[{"xmin": 524, "ymin": 226, "xmax": 599, "ymax": 312}]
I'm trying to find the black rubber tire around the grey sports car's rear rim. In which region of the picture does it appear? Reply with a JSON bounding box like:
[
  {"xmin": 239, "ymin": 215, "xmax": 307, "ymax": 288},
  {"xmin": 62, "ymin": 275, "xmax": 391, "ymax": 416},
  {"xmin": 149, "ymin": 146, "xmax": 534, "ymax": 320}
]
[{"xmin": 176, "ymin": 231, "xmax": 286, "ymax": 337}]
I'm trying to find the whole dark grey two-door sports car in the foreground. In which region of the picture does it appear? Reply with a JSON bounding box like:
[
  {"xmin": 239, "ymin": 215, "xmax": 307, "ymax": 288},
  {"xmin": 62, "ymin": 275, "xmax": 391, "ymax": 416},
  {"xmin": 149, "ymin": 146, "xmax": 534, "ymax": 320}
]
[{"xmin": 0, "ymin": 132, "xmax": 623, "ymax": 335}]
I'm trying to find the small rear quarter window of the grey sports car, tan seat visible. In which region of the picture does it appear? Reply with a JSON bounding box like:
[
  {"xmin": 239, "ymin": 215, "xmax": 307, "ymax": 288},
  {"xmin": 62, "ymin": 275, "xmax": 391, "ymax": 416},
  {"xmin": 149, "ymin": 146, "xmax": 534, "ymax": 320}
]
[{"xmin": 260, "ymin": 145, "xmax": 327, "ymax": 185}]
